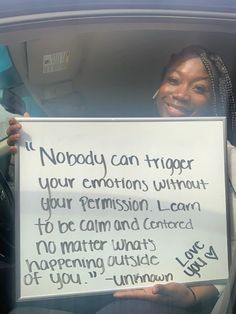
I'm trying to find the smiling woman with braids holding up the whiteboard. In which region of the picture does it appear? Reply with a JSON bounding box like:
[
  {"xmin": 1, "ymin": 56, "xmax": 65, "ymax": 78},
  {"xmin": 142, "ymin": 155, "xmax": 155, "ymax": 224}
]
[{"xmin": 7, "ymin": 46, "xmax": 236, "ymax": 314}]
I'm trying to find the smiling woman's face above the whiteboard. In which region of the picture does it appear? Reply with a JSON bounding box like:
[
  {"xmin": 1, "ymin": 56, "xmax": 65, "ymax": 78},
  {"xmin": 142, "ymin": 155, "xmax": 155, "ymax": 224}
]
[{"xmin": 156, "ymin": 57, "xmax": 211, "ymax": 117}]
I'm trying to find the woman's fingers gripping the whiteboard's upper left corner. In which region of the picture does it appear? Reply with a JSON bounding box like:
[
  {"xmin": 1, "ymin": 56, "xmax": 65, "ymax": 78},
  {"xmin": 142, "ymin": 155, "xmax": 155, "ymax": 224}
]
[{"xmin": 6, "ymin": 112, "xmax": 29, "ymax": 153}]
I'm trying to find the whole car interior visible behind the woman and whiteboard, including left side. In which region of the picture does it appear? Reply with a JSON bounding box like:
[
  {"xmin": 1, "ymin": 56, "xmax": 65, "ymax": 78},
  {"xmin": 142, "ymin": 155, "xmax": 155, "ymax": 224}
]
[{"xmin": 0, "ymin": 6, "xmax": 236, "ymax": 314}]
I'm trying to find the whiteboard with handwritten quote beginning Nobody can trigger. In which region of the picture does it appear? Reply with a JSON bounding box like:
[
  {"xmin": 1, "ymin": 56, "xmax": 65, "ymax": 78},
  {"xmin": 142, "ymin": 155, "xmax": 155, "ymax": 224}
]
[{"xmin": 17, "ymin": 118, "xmax": 228, "ymax": 300}]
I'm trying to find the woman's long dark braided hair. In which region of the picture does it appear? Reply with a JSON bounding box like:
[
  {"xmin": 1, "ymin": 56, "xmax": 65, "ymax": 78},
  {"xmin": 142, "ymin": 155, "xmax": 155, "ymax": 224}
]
[{"xmin": 162, "ymin": 46, "xmax": 236, "ymax": 145}]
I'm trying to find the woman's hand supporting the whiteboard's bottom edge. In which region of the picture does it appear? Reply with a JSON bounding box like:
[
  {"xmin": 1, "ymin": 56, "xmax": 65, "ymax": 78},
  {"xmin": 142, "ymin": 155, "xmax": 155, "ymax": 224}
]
[{"xmin": 113, "ymin": 283, "xmax": 196, "ymax": 307}]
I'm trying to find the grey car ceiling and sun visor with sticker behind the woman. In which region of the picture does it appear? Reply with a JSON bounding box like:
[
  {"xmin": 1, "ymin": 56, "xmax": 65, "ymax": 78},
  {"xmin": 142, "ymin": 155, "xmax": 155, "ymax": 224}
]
[{"xmin": 0, "ymin": 14, "xmax": 236, "ymax": 117}]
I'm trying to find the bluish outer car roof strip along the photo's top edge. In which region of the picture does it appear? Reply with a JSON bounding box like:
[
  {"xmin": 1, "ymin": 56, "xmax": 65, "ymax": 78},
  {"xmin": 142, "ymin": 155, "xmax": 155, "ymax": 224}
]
[{"xmin": 0, "ymin": 0, "xmax": 236, "ymax": 18}]
